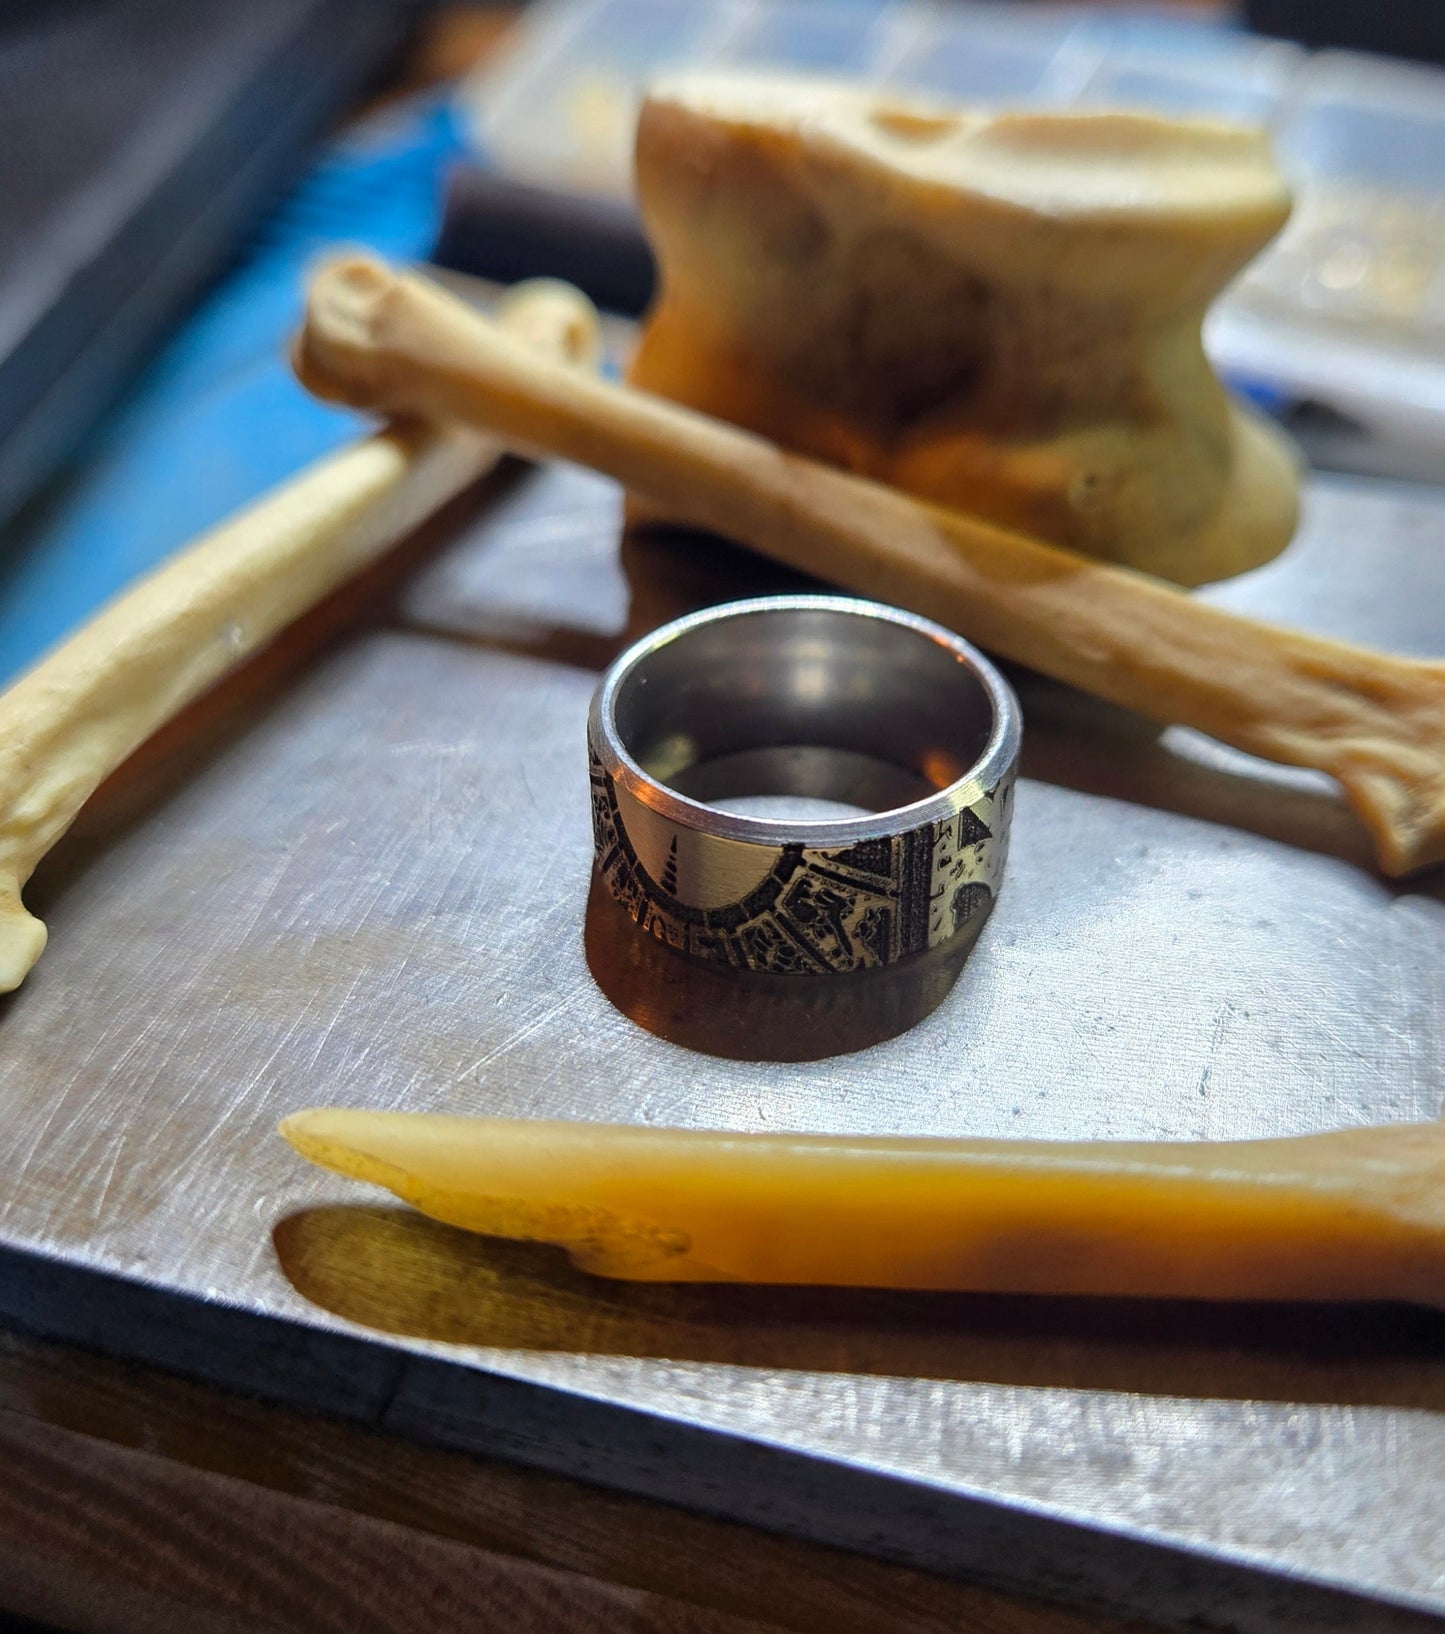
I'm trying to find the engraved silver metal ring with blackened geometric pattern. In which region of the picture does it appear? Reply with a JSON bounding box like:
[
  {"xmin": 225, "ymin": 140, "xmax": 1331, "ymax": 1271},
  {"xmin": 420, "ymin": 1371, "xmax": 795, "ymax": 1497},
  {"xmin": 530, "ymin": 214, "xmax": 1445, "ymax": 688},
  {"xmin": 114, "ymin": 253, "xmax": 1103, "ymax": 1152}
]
[{"xmin": 588, "ymin": 595, "xmax": 1022, "ymax": 975}]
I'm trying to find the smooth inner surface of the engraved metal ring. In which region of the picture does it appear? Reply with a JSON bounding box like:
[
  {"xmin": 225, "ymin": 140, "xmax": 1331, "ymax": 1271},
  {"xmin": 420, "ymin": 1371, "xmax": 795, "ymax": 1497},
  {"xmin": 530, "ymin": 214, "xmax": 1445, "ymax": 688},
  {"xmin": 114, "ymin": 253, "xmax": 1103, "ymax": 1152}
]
[{"xmin": 615, "ymin": 608, "xmax": 994, "ymax": 820}]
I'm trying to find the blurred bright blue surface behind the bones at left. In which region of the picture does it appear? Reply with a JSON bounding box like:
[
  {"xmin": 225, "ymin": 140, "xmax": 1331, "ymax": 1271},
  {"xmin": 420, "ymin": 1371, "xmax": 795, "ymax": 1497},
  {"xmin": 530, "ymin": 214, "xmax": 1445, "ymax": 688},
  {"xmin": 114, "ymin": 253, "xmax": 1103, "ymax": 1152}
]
[{"xmin": 0, "ymin": 96, "xmax": 461, "ymax": 685}]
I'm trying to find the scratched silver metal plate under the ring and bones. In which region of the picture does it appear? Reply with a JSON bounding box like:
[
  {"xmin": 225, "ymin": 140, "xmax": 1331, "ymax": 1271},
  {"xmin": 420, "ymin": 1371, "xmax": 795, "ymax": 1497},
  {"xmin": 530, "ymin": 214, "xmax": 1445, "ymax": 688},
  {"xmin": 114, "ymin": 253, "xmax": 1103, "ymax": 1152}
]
[{"xmin": 0, "ymin": 469, "xmax": 1445, "ymax": 1631}]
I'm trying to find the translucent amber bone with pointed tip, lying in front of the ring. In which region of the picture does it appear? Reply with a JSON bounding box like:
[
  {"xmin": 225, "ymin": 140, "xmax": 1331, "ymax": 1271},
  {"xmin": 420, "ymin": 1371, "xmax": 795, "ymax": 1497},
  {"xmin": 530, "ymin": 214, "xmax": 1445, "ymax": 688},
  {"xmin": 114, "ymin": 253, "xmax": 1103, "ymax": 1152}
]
[{"xmin": 281, "ymin": 1109, "xmax": 1445, "ymax": 1306}]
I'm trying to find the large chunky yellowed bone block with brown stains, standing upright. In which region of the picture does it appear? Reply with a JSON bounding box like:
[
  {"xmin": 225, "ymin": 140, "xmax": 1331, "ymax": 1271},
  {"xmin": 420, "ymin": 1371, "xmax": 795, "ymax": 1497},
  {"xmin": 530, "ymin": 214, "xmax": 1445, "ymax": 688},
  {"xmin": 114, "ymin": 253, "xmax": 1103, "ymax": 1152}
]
[{"xmin": 629, "ymin": 74, "xmax": 1298, "ymax": 585}]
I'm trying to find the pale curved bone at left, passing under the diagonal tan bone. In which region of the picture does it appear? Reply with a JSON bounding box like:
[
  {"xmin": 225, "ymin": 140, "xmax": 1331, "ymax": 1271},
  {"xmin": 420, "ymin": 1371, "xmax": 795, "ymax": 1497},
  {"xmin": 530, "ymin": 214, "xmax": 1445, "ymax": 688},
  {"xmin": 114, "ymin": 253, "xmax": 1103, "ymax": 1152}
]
[{"xmin": 0, "ymin": 281, "xmax": 597, "ymax": 992}]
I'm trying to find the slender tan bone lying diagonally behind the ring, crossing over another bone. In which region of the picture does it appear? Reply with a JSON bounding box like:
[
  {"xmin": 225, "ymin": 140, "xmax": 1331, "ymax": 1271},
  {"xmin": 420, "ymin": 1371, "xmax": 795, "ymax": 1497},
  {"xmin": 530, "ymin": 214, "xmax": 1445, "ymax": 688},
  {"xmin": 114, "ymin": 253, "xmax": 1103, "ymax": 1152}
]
[{"xmin": 296, "ymin": 258, "xmax": 1445, "ymax": 874}]
